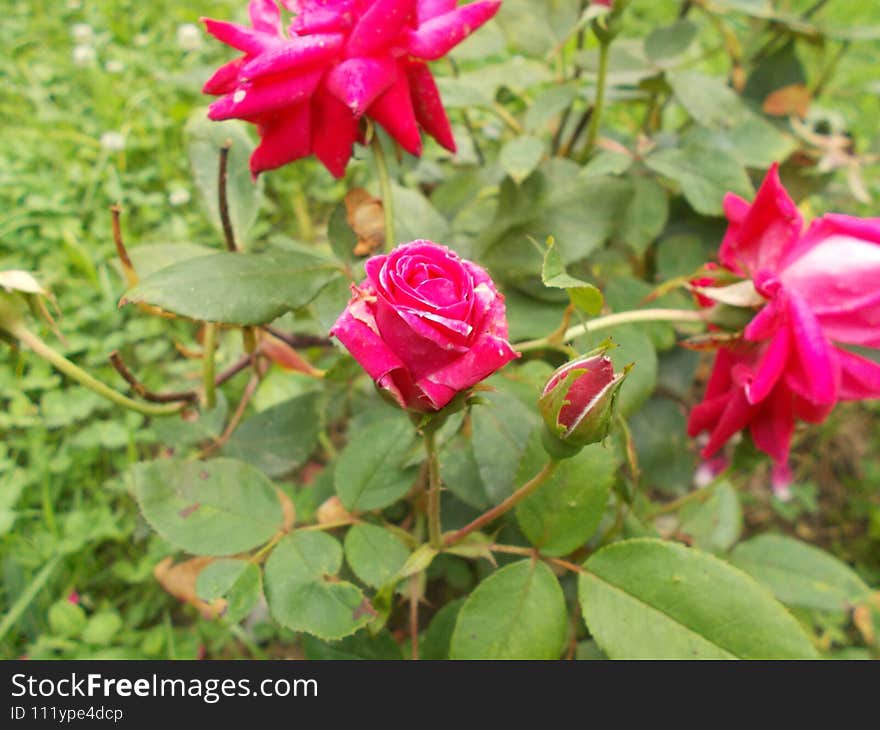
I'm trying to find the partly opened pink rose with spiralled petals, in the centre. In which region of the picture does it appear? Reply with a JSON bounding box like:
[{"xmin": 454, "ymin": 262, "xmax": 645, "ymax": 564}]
[{"xmin": 331, "ymin": 241, "xmax": 518, "ymax": 411}]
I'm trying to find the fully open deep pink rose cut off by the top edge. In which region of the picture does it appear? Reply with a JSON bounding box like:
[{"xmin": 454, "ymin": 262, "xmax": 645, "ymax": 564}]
[{"xmin": 203, "ymin": 0, "xmax": 501, "ymax": 177}]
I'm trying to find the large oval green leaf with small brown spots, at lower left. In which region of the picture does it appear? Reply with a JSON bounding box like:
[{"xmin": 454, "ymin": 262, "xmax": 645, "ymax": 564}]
[{"xmin": 129, "ymin": 459, "xmax": 283, "ymax": 555}]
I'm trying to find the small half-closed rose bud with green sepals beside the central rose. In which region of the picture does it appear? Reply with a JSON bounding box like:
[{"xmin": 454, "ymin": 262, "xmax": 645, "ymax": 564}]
[{"xmin": 538, "ymin": 354, "xmax": 628, "ymax": 459}]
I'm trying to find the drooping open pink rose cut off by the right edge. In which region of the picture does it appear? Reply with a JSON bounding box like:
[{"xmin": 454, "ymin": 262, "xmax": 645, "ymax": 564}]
[{"xmin": 688, "ymin": 165, "xmax": 880, "ymax": 490}]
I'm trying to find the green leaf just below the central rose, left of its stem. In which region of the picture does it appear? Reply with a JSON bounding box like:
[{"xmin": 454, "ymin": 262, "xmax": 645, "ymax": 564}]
[{"xmin": 334, "ymin": 418, "xmax": 418, "ymax": 510}]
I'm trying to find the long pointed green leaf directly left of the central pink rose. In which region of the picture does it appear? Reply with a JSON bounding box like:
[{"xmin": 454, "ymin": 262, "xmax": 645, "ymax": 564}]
[{"xmin": 120, "ymin": 251, "xmax": 340, "ymax": 325}]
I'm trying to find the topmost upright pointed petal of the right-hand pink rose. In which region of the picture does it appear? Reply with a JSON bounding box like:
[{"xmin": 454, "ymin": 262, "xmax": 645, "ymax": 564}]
[{"xmin": 719, "ymin": 164, "xmax": 803, "ymax": 275}]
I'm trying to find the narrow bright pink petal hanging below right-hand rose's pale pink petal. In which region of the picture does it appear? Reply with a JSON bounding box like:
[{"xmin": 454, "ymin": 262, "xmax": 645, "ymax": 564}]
[{"xmin": 786, "ymin": 292, "xmax": 840, "ymax": 404}]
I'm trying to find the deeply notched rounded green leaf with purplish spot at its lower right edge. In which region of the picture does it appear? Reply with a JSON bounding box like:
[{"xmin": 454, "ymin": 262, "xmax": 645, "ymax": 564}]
[{"xmin": 265, "ymin": 532, "xmax": 370, "ymax": 640}]
